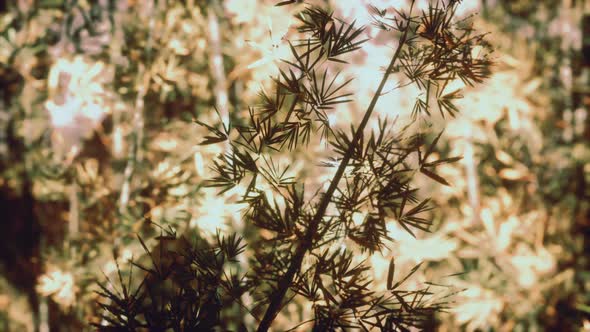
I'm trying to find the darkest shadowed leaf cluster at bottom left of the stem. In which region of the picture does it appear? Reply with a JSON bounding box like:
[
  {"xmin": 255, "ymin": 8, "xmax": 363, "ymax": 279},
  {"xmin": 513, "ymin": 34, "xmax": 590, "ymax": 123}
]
[{"xmin": 94, "ymin": 231, "xmax": 248, "ymax": 331}]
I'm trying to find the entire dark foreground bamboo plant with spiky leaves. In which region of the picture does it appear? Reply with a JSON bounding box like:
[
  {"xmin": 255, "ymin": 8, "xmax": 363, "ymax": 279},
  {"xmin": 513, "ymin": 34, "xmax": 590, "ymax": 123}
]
[{"xmin": 95, "ymin": 1, "xmax": 490, "ymax": 331}]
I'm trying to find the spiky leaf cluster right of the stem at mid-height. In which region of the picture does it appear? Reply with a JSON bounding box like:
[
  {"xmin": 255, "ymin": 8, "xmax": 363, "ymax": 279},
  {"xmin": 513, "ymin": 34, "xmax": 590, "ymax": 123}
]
[{"xmin": 330, "ymin": 120, "xmax": 461, "ymax": 252}]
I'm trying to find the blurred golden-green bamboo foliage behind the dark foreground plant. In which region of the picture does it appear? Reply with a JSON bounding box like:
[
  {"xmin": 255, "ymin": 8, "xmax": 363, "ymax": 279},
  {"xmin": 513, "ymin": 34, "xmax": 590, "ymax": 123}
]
[{"xmin": 0, "ymin": 0, "xmax": 590, "ymax": 331}]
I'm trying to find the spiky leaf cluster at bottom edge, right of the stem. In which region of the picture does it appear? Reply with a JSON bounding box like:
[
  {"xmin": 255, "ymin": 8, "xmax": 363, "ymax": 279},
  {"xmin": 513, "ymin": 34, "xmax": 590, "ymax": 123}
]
[{"xmin": 293, "ymin": 249, "xmax": 446, "ymax": 331}]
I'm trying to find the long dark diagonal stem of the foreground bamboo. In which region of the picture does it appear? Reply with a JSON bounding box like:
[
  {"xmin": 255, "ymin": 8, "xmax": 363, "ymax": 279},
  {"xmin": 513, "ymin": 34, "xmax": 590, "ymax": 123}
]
[{"xmin": 258, "ymin": 1, "xmax": 414, "ymax": 332}]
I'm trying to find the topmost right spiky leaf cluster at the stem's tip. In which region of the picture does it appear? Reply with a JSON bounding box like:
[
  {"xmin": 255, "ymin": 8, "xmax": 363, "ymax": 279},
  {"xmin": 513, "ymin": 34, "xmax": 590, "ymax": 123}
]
[{"xmin": 372, "ymin": 1, "xmax": 492, "ymax": 119}]
